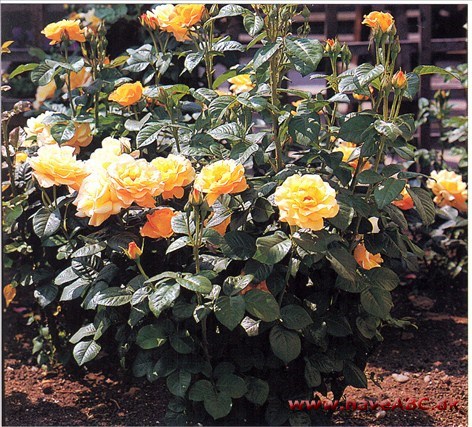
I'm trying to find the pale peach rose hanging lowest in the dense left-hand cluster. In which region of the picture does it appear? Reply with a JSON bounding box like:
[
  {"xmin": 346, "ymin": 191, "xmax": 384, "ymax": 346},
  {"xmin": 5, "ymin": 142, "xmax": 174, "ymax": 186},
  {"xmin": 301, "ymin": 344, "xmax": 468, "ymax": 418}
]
[{"xmin": 73, "ymin": 171, "xmax": 125, "ymax": 227}]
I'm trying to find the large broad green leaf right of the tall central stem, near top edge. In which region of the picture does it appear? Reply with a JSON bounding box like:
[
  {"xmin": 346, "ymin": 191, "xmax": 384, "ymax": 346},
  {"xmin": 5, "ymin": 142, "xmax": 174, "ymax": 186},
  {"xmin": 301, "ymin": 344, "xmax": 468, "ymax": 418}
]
[{"xmin": 285, "ymin": 36, "xmax": 323, "ymax": 76}]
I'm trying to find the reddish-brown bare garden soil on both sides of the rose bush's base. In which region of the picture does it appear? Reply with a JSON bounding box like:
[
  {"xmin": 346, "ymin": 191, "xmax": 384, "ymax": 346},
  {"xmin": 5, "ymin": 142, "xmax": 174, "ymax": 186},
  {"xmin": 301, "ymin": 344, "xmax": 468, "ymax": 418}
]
[{"xmin": 3, "ymin": 283, "xmax": 467, "ymax": 427}]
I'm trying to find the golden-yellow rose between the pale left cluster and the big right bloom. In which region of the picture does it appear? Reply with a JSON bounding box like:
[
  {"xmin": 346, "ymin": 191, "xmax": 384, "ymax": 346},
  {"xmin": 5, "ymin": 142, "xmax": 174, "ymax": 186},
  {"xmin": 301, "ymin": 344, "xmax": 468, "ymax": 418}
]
[{"xmin": 194, "ymin": 160, "xmax": 248, "ymax": 206}]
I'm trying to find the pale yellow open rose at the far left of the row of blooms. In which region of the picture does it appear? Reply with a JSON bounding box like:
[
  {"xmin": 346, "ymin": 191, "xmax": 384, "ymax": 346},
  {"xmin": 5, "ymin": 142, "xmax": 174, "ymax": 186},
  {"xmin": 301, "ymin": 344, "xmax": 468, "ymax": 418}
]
[{"xmin": 30, "ymin": 144, "xmax": 88, "ymax": 190}]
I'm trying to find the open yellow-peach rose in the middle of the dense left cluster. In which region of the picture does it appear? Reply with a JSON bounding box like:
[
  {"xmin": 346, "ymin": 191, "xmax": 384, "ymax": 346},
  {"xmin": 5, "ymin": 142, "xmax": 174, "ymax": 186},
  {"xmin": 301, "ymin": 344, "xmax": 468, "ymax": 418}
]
[{"xmin": 107, "ymin": 154, "xmax": 164, "ymax": 208}]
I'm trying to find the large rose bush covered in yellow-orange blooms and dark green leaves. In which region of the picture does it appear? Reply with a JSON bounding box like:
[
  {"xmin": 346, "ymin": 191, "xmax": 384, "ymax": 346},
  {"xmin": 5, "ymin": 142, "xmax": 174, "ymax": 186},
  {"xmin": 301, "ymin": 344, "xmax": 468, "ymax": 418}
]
[{"xmin": 2, "ymin": 4, "xmax": 466, "ymax": 425}]
